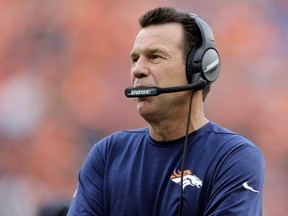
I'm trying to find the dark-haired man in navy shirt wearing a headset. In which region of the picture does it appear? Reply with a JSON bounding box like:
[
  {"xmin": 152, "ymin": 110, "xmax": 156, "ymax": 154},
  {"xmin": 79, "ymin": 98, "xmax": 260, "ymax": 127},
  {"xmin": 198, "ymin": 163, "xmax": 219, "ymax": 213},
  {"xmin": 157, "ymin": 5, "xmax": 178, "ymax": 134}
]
[{"xmin": 68, "ymin": 8, "xmax": 264, "ymax": 216}]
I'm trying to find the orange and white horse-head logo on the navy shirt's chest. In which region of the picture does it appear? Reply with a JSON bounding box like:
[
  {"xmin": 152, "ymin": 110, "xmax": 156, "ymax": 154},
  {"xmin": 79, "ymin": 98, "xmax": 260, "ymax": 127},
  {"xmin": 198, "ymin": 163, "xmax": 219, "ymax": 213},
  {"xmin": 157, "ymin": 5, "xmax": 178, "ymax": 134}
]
[{"xmin": 170, "ymin": 170, "xmax": 202, "ymax": 191}]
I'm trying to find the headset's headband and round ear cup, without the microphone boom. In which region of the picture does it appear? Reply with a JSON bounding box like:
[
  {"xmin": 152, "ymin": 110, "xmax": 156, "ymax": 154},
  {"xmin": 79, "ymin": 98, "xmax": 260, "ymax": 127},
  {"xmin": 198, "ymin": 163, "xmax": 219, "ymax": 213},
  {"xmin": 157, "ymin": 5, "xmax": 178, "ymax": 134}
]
[{"xmin": 186, "ymin": 13, "xmax": 221, "ymax": 85}]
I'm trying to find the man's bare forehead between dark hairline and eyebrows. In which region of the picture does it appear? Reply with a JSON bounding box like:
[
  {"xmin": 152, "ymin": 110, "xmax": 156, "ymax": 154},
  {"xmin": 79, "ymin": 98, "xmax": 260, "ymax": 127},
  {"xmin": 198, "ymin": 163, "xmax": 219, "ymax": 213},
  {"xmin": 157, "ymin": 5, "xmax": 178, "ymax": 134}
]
[{"xmin": 132, "ymin": 23, "xmax": 184, "ymax": 52}]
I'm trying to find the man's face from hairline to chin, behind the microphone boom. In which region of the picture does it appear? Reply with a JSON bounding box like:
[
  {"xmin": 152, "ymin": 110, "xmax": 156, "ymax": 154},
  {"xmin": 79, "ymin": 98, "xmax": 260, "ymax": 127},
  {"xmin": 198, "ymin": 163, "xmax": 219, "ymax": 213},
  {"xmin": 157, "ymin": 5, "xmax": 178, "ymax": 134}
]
[{"xmin": 130, "ymin": 23, "xmax": 187, "ymax": 121}]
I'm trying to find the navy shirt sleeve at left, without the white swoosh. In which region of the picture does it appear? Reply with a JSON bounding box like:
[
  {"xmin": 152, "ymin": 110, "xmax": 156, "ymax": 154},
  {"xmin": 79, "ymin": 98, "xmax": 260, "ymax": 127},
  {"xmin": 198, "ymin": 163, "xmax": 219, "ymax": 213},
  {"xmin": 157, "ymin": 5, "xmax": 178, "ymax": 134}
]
[{"xmin": 67, "ymin": 143, "xmax": 105, "ymax": 216}]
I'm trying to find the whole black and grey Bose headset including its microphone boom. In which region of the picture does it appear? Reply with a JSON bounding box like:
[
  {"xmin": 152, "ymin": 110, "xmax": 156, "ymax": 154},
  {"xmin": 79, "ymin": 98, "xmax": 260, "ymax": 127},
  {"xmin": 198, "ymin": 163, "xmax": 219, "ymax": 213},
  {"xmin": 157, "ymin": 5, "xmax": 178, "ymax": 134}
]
[{"xmin": 125, "ymin": 13, "xmax": 220, "ymax": 97}]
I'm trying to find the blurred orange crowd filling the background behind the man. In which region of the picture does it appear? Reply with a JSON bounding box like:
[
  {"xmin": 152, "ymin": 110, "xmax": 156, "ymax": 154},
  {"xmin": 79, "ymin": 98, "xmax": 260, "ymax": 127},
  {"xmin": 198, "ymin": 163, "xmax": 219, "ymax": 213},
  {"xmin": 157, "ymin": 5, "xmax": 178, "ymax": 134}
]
[{"xmin": 0, "ymin": 0, "xmax": 288, "ymax": 216}]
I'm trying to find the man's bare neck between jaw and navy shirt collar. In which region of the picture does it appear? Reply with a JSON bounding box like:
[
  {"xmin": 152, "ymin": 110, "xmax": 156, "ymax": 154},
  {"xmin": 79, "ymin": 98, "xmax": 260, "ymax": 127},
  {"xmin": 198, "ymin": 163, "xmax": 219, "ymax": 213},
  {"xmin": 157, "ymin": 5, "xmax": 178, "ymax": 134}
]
[{"xmin": 149, "ymin": 91, "xmax": 209, "ymax": 141}]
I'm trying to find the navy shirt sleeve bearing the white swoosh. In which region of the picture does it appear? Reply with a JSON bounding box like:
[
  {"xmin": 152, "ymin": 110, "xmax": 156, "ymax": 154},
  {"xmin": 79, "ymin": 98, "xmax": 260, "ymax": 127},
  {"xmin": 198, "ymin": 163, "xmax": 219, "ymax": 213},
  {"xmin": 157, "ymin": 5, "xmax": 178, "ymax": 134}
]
[{"xmin": 204, "ymin": 144, "xmax": 264, "ymax": 216}]
